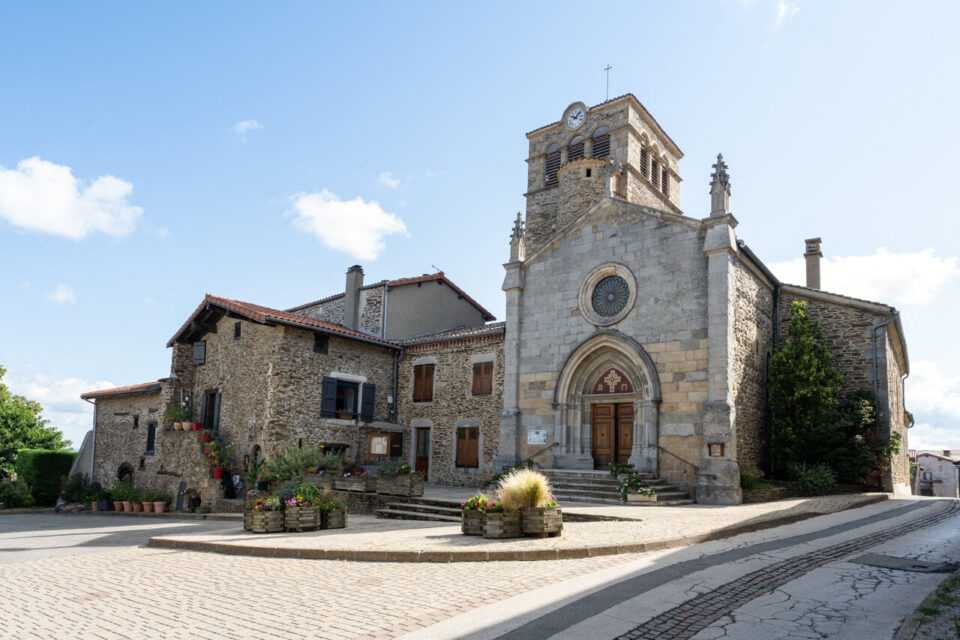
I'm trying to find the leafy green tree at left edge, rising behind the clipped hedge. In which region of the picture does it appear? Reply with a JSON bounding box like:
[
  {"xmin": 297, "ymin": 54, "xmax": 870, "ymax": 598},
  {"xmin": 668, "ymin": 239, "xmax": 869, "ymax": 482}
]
[{"xmin": 0, "ymin": 366, "xmax": 70, "ymax": 477}]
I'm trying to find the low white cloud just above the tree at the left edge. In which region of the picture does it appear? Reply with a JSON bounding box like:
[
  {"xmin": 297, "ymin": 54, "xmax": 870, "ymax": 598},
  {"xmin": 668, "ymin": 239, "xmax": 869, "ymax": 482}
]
[{"xmin": 3, "ymin": 374, "xmax": 117, "ymax": 449}]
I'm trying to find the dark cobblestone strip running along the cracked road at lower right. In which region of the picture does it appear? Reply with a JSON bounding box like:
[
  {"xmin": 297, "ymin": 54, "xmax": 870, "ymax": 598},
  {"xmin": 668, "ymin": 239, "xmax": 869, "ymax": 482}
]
[{"xmin": 618, "ymin": 502, "xmax": 960, "ymax": 640}]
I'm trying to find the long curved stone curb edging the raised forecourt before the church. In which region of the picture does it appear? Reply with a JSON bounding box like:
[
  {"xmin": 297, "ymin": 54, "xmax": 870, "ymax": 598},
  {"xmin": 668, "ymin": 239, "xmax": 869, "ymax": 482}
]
[{"xmin": 147, "ymin": 494, "xmax": 889, "ymax": 562}]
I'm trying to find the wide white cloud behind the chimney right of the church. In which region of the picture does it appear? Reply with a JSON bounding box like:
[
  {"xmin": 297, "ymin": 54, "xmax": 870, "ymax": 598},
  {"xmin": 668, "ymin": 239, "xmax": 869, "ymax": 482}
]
[{"xmin": 769, "ymin": 248, "xmax": 960, "ymax": 306}]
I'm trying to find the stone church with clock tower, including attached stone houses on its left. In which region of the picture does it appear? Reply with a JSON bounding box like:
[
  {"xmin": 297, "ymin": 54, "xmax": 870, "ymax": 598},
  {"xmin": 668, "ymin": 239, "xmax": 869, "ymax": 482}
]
[{"xmin": 81, "ymin": 94, "xmax": 912, "ymax": 504}]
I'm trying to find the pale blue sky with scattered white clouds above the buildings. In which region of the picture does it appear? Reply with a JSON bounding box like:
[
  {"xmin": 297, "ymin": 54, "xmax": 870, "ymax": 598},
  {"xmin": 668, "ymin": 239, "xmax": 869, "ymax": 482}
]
[{"xmin": 0, "ymin": 0, "xmax": 960, "ymax": 448}]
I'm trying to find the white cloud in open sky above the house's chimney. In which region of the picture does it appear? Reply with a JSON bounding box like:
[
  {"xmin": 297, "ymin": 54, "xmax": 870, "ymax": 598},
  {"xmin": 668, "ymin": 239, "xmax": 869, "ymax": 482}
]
[{"xmin": 290, "ymin": 189, "xmax": 409, "ymax": 260}]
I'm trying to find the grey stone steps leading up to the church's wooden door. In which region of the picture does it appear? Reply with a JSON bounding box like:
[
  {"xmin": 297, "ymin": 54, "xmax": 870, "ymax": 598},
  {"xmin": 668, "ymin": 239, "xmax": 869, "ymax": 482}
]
[{"xmin": 543, "ymin": 469, "xmax": 695, "ymax": 507}]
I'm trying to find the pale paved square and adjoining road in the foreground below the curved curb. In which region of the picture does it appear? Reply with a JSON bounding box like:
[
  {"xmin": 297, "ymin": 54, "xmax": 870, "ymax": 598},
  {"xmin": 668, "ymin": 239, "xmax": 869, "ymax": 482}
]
[{"xmin": 0, "ymin": 500, "xmax": 960, "ymax": 640}]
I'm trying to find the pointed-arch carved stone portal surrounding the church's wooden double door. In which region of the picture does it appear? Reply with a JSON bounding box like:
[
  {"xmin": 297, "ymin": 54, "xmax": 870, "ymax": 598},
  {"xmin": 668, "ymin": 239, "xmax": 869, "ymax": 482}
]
[{"xmin": 553, "ymin": 329, "xmax": 660, "ymax": 473}]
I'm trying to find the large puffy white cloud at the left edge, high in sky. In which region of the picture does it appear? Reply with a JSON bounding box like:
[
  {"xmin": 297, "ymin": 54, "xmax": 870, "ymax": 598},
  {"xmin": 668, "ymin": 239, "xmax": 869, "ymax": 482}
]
[{"xmin": 0, "ymin": 157, "xmax": 143, "ymax": 240}]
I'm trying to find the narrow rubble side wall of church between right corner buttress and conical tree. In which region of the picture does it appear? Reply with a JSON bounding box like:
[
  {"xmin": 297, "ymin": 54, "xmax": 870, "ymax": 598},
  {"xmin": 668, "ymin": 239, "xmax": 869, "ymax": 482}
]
[{"xmin": 730, "ymin": 262, "xmax": 773, "ymax": 469}]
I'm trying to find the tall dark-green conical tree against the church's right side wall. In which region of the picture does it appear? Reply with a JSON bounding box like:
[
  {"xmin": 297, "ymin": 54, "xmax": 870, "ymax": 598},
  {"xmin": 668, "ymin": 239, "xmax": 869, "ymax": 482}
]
[{"xmin": 768, "ymin": 302, "xmax": 843, "ymax": 475}]
